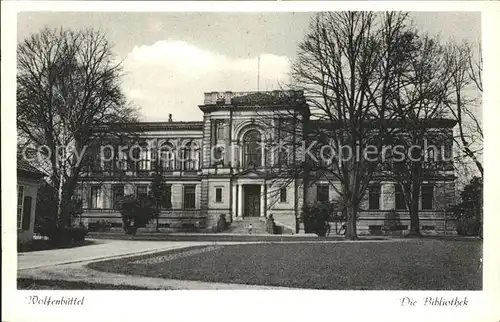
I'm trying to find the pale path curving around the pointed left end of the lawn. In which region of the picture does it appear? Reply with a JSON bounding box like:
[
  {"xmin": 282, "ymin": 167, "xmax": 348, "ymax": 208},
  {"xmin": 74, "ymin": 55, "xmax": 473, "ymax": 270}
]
[{"xmin": 17, "ymin": 239, "xmax": 294, "ymax": 290}]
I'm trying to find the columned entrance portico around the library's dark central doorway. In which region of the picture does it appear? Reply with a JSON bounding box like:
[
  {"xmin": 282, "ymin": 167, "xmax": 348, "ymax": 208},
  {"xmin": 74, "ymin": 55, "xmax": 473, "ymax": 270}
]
[{"xmin": 231, "ymin": 180, "xmax": 267, "ymax": 220}]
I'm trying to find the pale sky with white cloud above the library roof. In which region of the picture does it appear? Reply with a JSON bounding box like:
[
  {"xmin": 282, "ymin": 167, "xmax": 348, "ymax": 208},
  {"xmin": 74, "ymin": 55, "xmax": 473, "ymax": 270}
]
[{"xmin": 17, "ymin": 12, "xmax": 481, "ymax": 121}]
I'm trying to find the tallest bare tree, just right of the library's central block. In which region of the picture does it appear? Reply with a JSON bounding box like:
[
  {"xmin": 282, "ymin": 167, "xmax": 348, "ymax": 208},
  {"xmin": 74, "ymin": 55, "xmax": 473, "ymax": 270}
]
[{"xmin": 292, "ymin": 12, "xmax": 413, "ymax": 239}]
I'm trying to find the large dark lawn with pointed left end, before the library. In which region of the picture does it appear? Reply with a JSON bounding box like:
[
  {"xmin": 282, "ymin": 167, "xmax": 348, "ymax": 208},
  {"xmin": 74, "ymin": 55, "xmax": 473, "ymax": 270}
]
[{"xmin": 90, "ymin": 239, "xmax": 482, "ymax": 290}]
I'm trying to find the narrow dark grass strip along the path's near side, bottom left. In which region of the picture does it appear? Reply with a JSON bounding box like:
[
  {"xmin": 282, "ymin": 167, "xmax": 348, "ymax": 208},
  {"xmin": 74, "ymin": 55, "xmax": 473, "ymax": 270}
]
[{"xmin": 17, "ymin": 278, "xmax": 150, "ymax": 290}]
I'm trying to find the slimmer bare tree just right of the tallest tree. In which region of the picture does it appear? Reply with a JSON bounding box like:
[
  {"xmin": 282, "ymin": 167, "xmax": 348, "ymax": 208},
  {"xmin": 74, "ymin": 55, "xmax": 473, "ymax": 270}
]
[{"xmin": 385, "ymin": 34, "xmax": 455, "ymax": 235}]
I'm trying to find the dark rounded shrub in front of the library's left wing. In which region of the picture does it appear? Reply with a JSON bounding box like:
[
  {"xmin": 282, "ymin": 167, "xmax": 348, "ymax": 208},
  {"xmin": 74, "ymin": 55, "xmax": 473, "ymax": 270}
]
[{"xmin": 119, "ymin": 195, "xmax": 155, "ymax": 235}]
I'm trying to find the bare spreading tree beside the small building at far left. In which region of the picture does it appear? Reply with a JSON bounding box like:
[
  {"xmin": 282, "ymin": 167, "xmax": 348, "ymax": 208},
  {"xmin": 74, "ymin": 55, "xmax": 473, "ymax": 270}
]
[{"xmin": 17, "ymin": 29, "xmax": 135, "ymax": 225}]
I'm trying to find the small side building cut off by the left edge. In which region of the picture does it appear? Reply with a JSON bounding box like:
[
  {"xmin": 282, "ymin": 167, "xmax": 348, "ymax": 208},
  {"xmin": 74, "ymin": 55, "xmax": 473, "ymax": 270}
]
[{"xmin": 17, "ymin": 158, "xmax": 45, "ymax": 244}]
